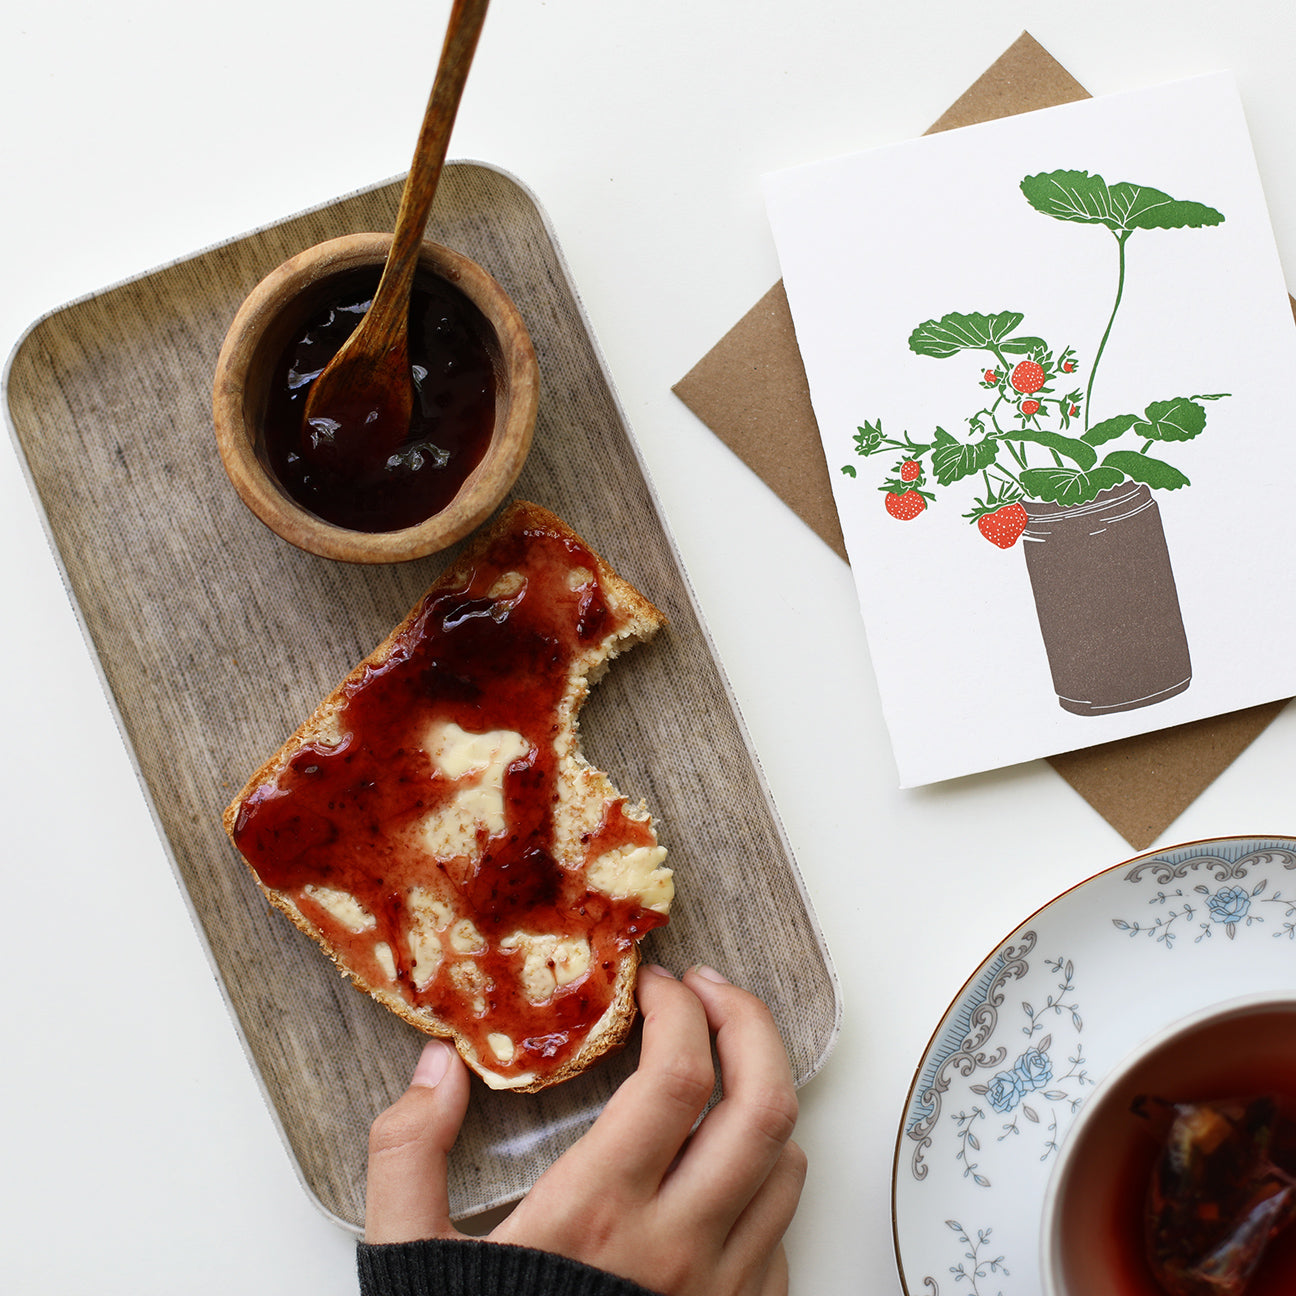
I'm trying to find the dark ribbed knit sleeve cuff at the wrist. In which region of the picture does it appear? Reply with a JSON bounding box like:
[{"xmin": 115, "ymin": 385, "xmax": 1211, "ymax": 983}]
[{"xmin": 355, "ymin": 1238, "xmax": 654, "ymax": 1296}]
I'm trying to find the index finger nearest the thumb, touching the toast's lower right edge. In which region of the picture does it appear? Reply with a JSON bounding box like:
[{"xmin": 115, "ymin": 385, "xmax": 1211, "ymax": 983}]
[{"xmin": 573, "ymin": 967, "xmax": 715, "ymax": 1195}]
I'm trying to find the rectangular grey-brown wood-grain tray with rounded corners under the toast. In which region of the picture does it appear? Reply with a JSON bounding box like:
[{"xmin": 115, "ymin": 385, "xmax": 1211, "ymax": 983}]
[{"xmin": 5, "ymin": 163, "xmax": 840, "ymax": 1229}]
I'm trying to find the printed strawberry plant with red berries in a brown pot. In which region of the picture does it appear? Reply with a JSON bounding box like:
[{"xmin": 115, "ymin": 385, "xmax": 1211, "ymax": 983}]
[{"xmin": 841, "ymin": 171, "xmax": 1227, "ymax": 715}]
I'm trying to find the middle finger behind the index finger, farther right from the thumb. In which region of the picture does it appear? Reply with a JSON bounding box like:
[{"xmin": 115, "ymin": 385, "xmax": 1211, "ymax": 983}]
[{"xmin": 670, "ymin": 968, "xmax": 797, "ymax": 1230}]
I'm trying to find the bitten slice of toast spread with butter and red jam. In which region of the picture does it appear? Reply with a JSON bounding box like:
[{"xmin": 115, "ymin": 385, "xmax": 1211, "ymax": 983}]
[{"xmin": 224, "ymin": 502, "xmax": 674, "ymax": 1093}]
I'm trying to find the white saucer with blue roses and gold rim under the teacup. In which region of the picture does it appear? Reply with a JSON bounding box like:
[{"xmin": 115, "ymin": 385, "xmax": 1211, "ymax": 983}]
[{"xmin": 892, "ymin": 837, "xmax": 1296, "ymax": 1296}]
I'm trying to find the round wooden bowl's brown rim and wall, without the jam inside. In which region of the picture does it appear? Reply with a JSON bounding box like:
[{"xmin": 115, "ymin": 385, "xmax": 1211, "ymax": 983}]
[{"xmin": 211, "ymin": 233, "xmax": 539, "ymax": 562}]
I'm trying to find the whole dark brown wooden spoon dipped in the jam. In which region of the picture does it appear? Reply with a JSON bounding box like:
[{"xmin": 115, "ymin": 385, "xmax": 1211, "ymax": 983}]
[{"xmin": 302, "ymin": 0, "xmax": 489, "ymax": 473}]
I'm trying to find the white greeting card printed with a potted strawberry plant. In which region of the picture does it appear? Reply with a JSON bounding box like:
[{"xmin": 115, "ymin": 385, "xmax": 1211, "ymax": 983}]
[{"xmin": 766, "ymin": 74, "xmax": 1296, "ymax": 785}]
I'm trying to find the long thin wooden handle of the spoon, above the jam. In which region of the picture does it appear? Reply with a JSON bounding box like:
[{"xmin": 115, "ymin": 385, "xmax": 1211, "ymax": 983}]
[{"xmin": 371, "ymin": 0, "xmax": 489, "ymax": 334}]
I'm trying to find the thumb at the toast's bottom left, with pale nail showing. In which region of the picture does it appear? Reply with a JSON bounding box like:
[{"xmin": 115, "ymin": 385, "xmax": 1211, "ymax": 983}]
[{"xmin": 364, "ymin": 1039, "xmax": 469, "ymax": 1243}]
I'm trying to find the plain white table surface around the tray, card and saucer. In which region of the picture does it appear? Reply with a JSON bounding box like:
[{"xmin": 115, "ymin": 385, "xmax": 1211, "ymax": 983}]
[{"xmin": 0, "ymin": 0, "xmax": 1296, "ymax": 1296}]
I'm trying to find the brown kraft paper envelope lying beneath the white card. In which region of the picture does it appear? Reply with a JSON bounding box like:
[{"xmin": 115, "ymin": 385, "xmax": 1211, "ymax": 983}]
[{"xmin": 674, "ymin": 34, "xmax": 1296, "ymax": 850}]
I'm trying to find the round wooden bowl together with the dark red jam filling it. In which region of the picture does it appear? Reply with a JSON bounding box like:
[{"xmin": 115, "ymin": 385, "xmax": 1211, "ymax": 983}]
[{"xmin": 213, "ymin": 235, "xmax": 539, "ymax": 562}]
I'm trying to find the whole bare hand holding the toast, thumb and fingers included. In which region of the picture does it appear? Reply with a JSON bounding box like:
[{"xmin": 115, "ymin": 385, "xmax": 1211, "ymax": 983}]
[{"xmin": 364, "ymin": 967, "xmax": 806, "ymax": 1296}]
